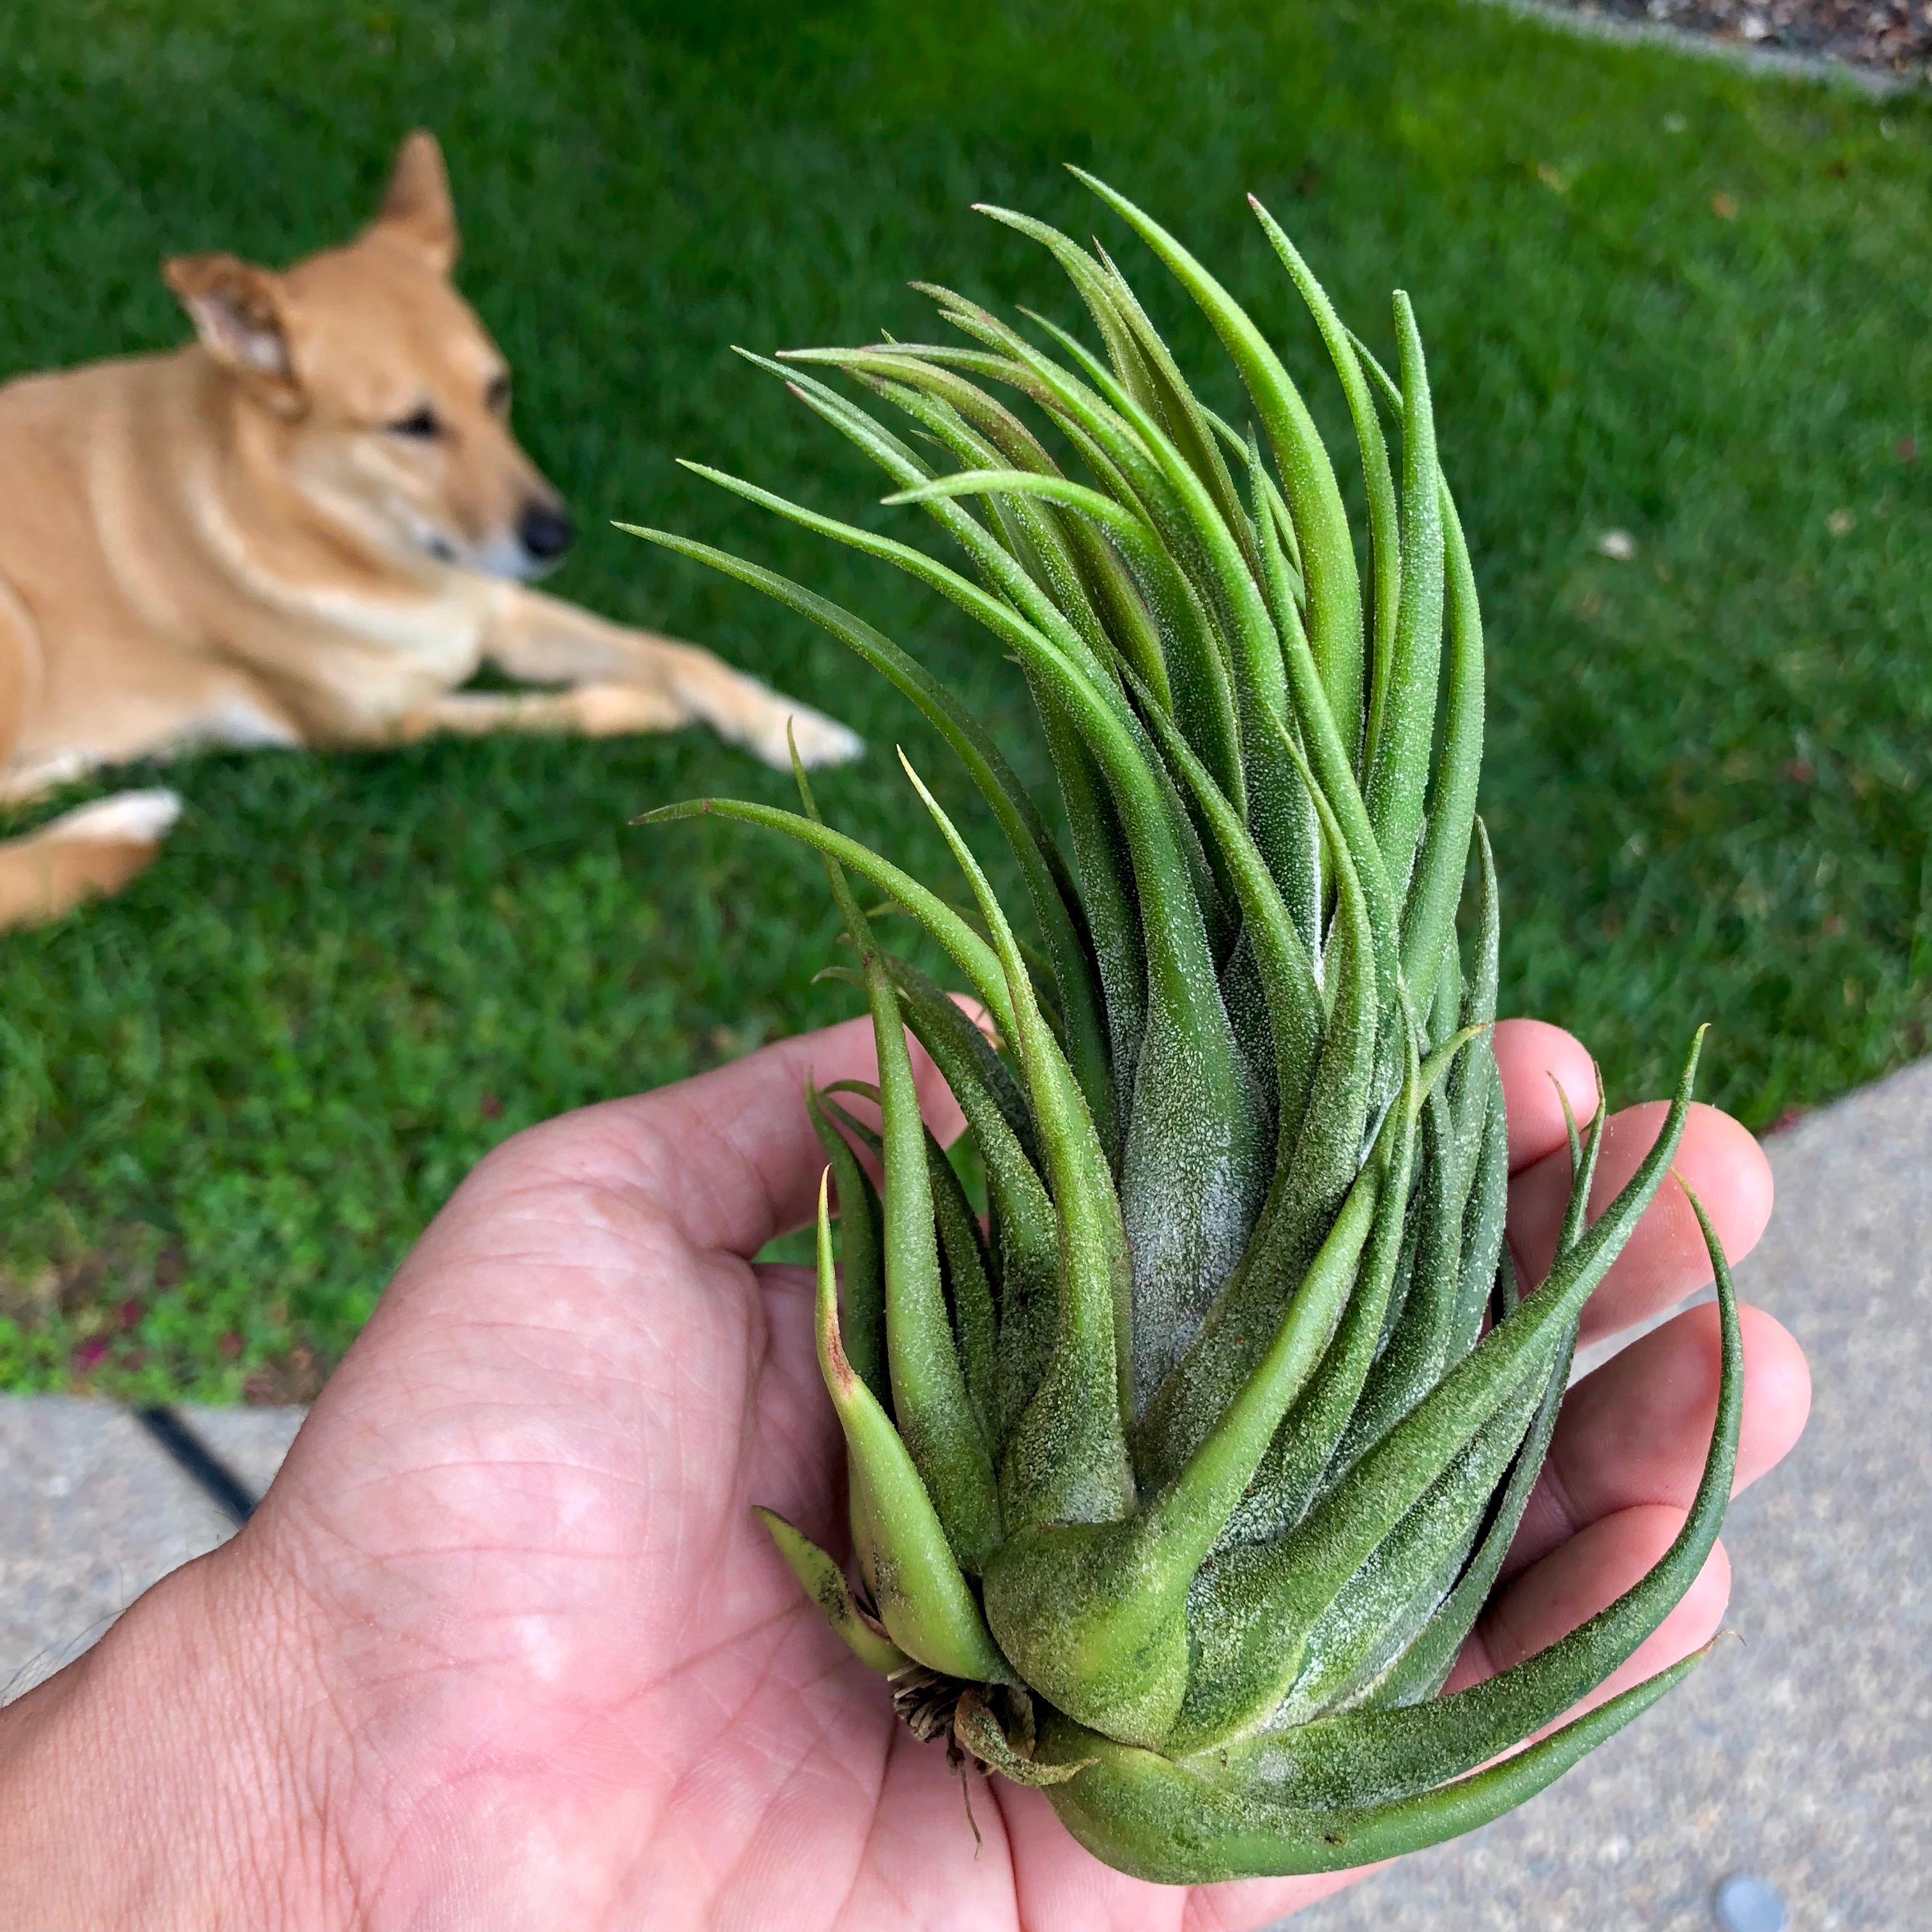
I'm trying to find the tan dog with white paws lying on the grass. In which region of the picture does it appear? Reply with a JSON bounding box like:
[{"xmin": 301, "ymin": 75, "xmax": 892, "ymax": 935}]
[{"xmin": 0, "ymin": 134, "xmax": 860, "ymax": 928}]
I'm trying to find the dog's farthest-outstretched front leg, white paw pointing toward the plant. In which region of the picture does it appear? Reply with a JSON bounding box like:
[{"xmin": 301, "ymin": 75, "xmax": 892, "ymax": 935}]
[{"xmin": 483, "ymin": 589, "xmax": 864, "ymax": 771}]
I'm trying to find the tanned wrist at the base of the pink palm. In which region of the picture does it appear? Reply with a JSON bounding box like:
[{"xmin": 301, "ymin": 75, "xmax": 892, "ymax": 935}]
[{"xmin": 0, "ymin": 1536, "xmax": 344, "ymax": 1932}]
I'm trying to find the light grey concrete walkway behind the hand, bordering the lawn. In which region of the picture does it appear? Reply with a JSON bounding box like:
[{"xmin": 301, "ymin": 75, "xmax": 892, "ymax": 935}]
[{"xmin": 0, "ymin": 1062, "xmax": 1932, "ymax": 1932}]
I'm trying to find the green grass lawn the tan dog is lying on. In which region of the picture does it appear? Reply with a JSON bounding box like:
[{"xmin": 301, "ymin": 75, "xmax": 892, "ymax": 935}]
[{"xmin": 0, "ymin": 0, "xmax": 1932, "ymax": 1399}]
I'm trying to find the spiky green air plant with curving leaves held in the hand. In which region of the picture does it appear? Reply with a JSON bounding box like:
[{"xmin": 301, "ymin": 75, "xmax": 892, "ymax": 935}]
[{"xmin": 625, "ymin": 176, "xmax": 1741, "ymax": 1882}]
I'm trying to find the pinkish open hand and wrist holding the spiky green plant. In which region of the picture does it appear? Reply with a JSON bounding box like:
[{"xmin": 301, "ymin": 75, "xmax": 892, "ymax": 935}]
[{"xmin": 0, "ymin": 1020, "xmax": 1808, "ymax": 1932}]
